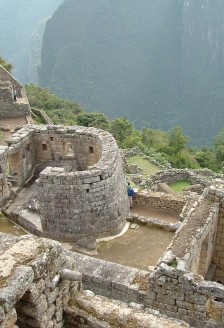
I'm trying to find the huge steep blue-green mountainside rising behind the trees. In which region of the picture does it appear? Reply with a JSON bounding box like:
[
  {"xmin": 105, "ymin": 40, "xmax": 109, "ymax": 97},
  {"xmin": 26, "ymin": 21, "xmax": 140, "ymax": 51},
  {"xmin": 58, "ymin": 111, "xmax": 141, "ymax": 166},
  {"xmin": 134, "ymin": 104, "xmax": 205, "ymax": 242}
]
[{"xmin": 39, "ymin": 0, "xmax": 224, "ymax": 144}]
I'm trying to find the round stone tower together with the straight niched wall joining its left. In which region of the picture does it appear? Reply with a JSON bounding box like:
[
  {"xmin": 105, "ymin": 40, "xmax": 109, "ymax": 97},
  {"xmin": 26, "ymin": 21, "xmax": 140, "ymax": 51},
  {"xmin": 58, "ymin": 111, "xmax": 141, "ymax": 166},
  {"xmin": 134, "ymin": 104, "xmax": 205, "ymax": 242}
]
[{"xmin": 4, "ymin": 125, "xmax": 129, "ymax": 242}]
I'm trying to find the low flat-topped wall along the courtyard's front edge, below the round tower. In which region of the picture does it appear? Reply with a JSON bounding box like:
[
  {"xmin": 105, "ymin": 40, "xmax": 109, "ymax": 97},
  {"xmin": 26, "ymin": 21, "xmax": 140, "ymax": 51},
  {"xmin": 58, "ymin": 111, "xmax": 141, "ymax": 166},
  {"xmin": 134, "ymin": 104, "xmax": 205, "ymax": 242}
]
[{"xmin": 67, "ymin": 251, "xmax": 149, "ymax": 303}]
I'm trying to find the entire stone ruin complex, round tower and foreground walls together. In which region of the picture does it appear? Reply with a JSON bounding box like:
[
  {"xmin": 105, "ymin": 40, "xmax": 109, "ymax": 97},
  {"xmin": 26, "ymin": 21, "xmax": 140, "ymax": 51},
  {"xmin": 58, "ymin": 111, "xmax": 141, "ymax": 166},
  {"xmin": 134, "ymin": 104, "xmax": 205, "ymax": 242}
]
[{"xmin": 0, "ymin": 74, "xmax": 224, "ymax": 328}]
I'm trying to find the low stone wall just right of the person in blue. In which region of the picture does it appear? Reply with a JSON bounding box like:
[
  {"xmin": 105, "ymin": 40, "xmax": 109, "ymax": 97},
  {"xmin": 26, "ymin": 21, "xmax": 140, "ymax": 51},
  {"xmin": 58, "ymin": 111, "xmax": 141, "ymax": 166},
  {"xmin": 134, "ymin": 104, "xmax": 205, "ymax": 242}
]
[{"xmin": 133, "ymin": 191, "xmax": 188, "ymax": 212}]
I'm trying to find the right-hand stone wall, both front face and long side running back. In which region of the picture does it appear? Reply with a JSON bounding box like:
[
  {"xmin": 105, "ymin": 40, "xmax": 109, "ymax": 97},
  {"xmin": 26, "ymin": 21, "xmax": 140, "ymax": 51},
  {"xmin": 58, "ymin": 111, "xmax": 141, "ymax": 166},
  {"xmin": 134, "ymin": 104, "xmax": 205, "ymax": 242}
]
[{"xmin": 148, "ymin": 187, "xmax": 224, "ymax": 327}]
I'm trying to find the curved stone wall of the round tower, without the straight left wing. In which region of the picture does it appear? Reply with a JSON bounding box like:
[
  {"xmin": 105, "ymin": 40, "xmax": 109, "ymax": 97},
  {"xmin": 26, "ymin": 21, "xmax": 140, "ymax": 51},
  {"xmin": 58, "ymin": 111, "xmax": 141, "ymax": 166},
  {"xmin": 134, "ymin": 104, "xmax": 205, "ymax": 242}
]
[{"xmin": 34, "ymin": 127, "xmax": 128, "ymax": 241}]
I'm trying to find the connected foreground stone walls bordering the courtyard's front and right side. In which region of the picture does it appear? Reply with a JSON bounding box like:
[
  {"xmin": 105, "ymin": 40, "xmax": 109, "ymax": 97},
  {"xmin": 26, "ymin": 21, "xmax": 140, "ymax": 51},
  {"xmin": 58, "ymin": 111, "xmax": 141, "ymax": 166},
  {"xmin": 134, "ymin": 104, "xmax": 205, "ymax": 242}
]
[{"xmin": 0, "ymin": 179, "xmax": 224, "ymax": 328}]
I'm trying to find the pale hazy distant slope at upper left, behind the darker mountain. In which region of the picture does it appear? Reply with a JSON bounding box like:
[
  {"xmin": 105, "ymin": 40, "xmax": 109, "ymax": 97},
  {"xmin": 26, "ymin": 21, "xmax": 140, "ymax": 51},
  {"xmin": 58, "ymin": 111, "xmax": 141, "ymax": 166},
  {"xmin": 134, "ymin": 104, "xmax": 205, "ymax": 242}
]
[{"xmin": 0, "ymin": 0, "xmax": 63, "ymax": 83}]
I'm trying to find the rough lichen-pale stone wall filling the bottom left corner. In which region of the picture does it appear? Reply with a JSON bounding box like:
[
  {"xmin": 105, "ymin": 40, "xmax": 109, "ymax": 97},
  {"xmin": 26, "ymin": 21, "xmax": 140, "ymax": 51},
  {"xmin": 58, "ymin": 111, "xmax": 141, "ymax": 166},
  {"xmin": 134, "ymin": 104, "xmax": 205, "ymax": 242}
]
[{"xmin": 0, "ymin": 234, "xmax": 80, "ymax": 328}]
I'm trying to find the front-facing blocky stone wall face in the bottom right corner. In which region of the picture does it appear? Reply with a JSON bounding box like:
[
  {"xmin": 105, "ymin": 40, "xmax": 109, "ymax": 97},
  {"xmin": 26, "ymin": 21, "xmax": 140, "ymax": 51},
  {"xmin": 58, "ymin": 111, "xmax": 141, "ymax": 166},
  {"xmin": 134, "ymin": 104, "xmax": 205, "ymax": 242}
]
[{"xmin": 147, "ymin": 262, "xmax": 224, "ymax": 328}]
